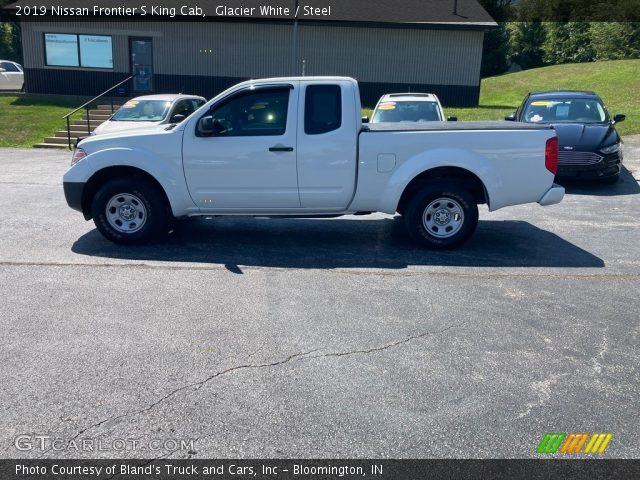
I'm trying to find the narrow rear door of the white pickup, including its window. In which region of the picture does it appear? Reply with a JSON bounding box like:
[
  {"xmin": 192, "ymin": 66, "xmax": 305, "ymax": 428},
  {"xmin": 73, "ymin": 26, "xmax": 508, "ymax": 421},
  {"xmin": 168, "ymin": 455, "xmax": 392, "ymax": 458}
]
[{"xmin": 298, "ymin": 81, "xmax": 360, "ymax": 210}]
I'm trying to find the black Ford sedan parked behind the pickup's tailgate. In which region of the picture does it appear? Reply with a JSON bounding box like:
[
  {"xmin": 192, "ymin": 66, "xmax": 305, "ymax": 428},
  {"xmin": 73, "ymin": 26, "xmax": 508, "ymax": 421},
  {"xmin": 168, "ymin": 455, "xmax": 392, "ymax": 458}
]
[{"xmin": 505, "ymin": 90, "xmax": 626, "ymax": 183}]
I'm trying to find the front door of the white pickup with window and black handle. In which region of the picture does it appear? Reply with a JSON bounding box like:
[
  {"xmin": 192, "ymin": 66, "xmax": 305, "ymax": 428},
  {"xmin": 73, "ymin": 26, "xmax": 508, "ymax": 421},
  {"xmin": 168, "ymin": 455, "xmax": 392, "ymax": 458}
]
[{"xmin": 183, "ymin": 85, "xmax": 300, "ymax": 210}]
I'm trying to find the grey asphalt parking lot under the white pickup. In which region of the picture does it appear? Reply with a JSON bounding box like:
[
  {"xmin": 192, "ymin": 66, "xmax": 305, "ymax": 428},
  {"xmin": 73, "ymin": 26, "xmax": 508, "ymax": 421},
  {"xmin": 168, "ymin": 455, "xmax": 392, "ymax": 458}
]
[{"xmin": 0, "ymin": 137, "xmax": 640, "ymax": 458}]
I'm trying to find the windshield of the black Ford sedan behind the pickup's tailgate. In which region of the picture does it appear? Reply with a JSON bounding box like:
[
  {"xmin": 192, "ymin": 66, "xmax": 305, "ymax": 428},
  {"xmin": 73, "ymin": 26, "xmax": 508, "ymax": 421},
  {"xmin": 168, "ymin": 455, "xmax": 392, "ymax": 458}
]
[{"xmin": 523, "ymin": 98, "xmax": 609, "ymax": 123}]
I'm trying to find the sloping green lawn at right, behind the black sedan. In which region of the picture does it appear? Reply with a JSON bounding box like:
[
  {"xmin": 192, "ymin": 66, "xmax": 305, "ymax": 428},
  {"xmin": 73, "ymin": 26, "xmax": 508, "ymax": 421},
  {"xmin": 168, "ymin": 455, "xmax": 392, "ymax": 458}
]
[{"xmin": 363, "ymin": 60, "xmax": 640, "ymax": 135}]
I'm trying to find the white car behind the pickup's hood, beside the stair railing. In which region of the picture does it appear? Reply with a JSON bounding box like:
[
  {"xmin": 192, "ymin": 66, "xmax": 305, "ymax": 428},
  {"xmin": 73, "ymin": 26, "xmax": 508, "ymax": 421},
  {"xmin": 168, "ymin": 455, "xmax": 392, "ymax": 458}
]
[{"xmin": 91, "ymin": 94, "xmax": 207, "ymax": 135}]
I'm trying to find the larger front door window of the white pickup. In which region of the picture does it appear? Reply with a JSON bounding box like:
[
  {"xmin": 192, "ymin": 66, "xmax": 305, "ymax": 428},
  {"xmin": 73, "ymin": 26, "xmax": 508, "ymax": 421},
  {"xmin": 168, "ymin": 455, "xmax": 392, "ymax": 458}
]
[{"xmin": 211, "ymin": 88, "xmax": 289, "ymax": 137}]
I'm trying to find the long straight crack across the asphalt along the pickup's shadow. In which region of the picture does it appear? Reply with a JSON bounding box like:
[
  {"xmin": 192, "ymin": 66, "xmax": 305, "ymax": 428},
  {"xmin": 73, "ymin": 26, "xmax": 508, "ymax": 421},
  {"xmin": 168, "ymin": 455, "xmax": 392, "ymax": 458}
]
[{"xmin": 0, "ymin": 260, "xmax": 640, "ymax": 281}]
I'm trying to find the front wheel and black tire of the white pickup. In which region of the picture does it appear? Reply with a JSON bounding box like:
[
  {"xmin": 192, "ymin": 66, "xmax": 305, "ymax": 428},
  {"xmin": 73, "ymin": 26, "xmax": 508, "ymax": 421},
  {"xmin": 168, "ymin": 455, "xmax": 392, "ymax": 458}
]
[{"xmin": 91, "ymin": 177, "xmax": 171, "ymax": 245}]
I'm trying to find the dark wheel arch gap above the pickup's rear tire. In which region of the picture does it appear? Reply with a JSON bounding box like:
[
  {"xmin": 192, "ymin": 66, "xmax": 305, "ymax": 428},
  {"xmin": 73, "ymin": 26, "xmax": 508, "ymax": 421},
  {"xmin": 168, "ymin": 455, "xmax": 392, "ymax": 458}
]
[{"xmin": 396, "ymin": 166, "xmax": 490, "ymax": 213}]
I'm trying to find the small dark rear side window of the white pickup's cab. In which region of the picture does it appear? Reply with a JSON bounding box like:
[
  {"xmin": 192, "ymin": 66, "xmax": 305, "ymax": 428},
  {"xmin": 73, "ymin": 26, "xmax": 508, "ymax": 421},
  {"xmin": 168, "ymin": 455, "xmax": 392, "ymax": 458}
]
[{"xmin": 304, "ymin": 85, "xmax": 342, "ymax": 135}]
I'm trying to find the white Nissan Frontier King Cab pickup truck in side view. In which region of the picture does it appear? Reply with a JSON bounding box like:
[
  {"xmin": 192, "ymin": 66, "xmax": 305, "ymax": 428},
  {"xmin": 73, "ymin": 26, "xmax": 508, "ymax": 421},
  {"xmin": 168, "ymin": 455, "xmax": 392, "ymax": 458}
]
[{"xmin": 64, "ymin": 77, "xmax": 564, "ymax": 248}]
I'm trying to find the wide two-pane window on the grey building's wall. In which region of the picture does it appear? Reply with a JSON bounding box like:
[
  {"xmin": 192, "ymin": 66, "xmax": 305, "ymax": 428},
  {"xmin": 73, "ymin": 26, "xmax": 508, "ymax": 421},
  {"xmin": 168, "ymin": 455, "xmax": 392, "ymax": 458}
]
[{"xmin": 44, "ymin": 33, "xmax": 113, "ymax": 69}]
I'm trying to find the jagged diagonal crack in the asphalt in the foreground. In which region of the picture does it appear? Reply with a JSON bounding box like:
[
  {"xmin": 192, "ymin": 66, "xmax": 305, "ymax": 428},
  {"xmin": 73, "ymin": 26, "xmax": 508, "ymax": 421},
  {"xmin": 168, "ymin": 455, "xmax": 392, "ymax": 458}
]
[{"xmin": 71, "ymin": 321, "xmax": 468, "ymax": 440}]
